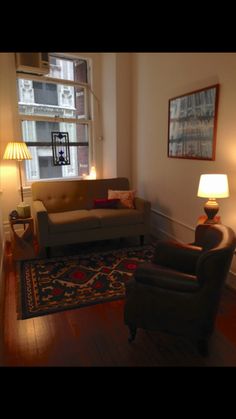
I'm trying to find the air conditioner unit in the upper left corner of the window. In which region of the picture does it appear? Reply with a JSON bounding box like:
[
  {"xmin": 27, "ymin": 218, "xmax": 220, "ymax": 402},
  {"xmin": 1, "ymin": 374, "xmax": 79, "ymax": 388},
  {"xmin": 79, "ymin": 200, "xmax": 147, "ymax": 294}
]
[{"xmin": 15, "ymin": 52, "xmax": 50, "ymax": 75}]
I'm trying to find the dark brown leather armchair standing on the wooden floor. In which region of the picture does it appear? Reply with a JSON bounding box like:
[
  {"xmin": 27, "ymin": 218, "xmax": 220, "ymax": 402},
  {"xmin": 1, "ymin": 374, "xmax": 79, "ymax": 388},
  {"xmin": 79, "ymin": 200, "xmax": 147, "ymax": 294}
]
[{"xmin": 124, "ymin": 224, "xmax": 236, "ymax": 355}]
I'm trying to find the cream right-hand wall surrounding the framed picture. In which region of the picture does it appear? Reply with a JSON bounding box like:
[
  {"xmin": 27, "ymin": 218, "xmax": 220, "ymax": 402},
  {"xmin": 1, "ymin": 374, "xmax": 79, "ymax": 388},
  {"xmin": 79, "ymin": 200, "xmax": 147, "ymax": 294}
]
[{"xmin": 132, "ymin": 53, "xmax": 236, "ymax": 278}]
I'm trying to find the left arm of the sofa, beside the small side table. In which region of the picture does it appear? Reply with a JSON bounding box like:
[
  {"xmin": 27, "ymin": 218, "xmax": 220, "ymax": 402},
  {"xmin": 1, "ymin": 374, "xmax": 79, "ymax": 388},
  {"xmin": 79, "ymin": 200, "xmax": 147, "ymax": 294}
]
[{"xmin": 32, "ymin": 201, "xmax": 48, "ymax": 246}]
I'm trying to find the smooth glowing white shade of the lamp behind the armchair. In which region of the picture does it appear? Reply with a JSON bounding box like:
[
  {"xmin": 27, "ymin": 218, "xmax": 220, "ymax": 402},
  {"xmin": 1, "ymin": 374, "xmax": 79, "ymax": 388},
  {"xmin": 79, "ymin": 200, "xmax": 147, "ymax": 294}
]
[{"xmin": 197, "ymin": 174, "xmax": 229, "ymax": 198}]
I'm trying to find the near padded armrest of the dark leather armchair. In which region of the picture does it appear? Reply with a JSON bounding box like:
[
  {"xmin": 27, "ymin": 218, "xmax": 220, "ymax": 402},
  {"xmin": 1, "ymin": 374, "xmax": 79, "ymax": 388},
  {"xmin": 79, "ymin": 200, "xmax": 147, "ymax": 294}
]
[{"xmin": 135, "ymin": 263, "xmax": 200, "ymax": 292}]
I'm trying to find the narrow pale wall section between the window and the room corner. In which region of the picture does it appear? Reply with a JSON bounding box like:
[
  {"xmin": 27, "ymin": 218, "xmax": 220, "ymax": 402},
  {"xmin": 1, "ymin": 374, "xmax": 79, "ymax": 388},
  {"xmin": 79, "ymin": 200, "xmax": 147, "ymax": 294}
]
[{"xmin": 102, "ymin": 53, "xmax": 132, "ymax": 181}]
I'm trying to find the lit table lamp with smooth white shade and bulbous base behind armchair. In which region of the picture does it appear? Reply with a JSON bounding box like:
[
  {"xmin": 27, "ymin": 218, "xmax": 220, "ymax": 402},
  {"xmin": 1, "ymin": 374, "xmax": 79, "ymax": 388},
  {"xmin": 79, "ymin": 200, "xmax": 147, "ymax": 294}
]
[{"xmin": 197, "ymin": 174, "xmax": 229, "ymax": 224}]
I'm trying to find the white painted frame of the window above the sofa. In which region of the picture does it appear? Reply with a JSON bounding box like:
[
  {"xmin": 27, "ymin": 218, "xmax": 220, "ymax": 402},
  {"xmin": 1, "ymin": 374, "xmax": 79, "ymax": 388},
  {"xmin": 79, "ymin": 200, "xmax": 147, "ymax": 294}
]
[{"xmin": 16, "ymin": 53, "xmax": 94, "ymax": 187}]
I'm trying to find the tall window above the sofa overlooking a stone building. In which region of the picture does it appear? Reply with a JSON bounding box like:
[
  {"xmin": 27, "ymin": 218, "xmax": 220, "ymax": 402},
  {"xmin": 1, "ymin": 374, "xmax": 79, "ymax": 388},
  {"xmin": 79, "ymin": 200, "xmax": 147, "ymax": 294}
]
[{"xmin": 17, "ymin": 54, "xmax": 92, "ymax": 182}]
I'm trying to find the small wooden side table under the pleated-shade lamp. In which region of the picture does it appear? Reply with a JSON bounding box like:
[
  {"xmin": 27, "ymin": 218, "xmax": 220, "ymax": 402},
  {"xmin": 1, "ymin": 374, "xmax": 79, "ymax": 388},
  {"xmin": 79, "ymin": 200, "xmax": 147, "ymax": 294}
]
[{"xmin": 9, "ymin": 217, "xmax": 36, "ymax": 260}]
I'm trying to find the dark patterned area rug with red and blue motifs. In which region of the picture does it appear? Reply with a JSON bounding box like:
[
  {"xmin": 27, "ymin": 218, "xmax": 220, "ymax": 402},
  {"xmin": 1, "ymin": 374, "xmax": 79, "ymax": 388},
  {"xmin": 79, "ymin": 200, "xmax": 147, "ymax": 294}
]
[{"xmin": 18, "ymin": 245, "xmax": 154, "ymax": 319}]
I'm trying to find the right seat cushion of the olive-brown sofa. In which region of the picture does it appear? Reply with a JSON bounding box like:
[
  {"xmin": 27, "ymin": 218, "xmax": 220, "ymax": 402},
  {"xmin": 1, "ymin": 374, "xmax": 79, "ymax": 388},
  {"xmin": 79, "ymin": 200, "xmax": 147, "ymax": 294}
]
[{"xmin": 90, "ymin": 208, "xmax": 144, "ymax": 227}]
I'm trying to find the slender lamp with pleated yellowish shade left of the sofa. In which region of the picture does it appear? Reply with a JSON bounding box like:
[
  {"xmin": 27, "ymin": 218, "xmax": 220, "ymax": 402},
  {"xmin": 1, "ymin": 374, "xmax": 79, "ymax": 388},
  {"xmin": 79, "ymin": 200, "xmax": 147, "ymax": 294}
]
[{"xmin": 3, "ymin": 141, "xmax": 32, "ymax": 218}]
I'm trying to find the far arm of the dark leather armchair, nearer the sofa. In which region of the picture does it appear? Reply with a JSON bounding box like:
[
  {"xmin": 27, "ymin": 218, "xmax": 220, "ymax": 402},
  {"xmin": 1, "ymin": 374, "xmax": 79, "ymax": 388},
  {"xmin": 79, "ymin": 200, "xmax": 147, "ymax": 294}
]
[{"xmin": 153, "ymin": 240, "xmax": 203, "ymax": 275}]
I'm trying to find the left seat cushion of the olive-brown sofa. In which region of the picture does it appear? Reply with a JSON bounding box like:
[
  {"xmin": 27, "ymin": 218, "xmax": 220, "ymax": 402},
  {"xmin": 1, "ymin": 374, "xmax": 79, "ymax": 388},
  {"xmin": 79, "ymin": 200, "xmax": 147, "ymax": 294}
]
[{"xmin": 48, "ymin": 210, "xmax": 101, "ymax": 233}]
